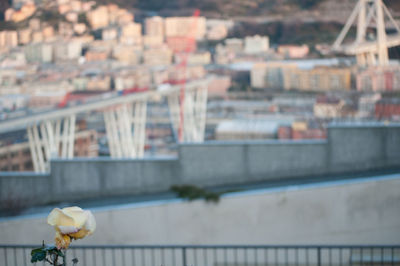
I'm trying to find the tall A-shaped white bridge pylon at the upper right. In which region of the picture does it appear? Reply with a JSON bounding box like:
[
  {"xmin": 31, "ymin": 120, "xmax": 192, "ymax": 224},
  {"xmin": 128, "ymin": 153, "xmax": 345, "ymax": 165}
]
[{"xmin": 332, "ymin": 0, "xmax": 400, "ymax": 66}]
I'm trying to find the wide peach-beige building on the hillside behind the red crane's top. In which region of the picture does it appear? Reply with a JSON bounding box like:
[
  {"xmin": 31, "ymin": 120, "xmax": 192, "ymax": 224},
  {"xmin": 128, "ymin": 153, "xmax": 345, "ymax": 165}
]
[{"xmin": 165, "ymin": 17, "xmax": 206, "ymax": 40}]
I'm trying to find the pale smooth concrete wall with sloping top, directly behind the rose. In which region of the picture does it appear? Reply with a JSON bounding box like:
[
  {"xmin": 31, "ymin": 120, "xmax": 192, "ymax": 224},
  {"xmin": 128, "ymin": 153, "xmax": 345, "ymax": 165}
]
[{"xmin": 0, "ymin": 174, "xmax": 400, "ymax": 245}]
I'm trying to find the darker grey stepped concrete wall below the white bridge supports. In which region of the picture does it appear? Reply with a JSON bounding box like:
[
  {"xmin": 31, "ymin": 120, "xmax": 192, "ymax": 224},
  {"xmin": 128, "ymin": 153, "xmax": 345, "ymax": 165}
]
[{"xmin": 0, "ymin": 125, "xmax": 400, "ymax": 210}]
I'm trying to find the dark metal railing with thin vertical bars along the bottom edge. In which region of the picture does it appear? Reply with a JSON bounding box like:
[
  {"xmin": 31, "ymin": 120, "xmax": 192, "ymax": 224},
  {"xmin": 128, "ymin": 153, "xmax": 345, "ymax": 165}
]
[{"xmin": 0, "ymin": 245, "xmax": 400, "ymax": 266}]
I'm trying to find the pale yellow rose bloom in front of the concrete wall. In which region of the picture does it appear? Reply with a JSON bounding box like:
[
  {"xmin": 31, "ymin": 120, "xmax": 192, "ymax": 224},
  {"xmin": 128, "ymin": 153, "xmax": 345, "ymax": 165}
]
[{"xmin": 47, "ymin": 207, "xmax": 96, "ymax": 249}]
